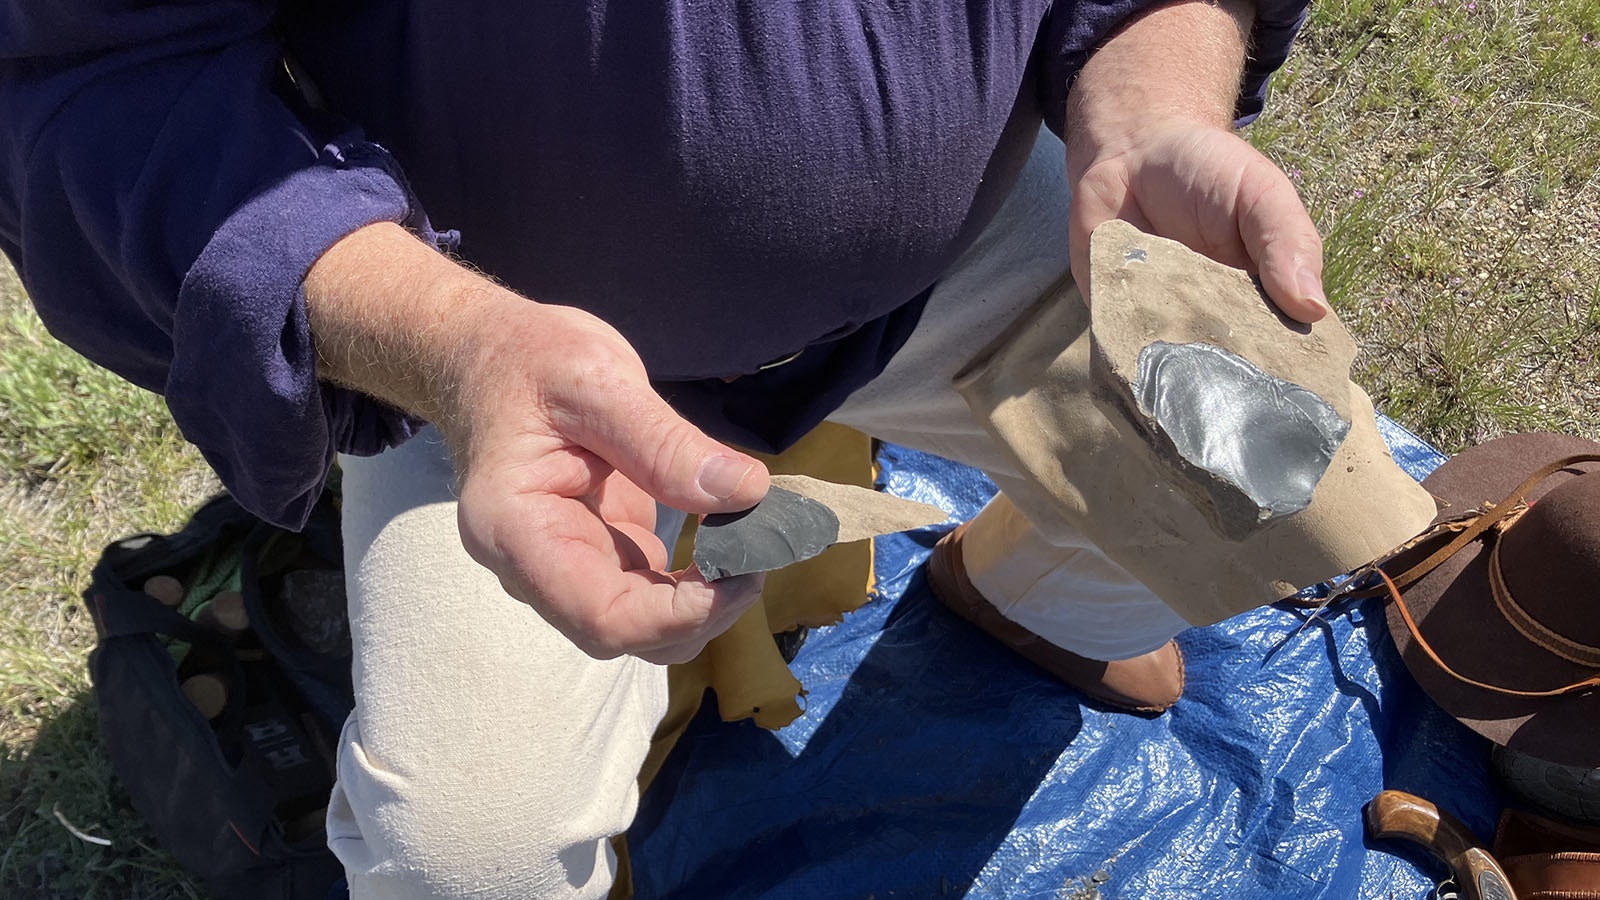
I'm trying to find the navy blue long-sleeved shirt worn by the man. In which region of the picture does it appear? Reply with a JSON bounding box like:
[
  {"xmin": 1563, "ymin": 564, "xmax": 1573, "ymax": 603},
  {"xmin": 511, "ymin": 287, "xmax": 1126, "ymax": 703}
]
[{"xmin": 0, "ymin": 0, "xmax": 1306, "ymax": 527}]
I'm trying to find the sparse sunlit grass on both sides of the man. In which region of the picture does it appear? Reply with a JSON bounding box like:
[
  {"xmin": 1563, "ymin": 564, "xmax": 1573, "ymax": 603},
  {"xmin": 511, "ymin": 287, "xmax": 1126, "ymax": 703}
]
[{"xmin": 0, "ymin": 0, "xmax": 1600, "ymax": 900}]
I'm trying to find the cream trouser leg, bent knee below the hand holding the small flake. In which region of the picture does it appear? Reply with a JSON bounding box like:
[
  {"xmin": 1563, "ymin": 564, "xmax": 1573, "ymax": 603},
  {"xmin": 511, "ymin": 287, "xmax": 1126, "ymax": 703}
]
[{"xmin": 328, "ymin": 431, "xmax": 667, "ymax": 900}]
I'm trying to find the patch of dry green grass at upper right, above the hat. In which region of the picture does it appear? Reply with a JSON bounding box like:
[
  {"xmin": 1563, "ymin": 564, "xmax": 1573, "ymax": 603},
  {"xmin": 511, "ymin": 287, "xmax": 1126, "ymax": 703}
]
[{"xmin": 1251, "ymin": 0, "xmax": 1600, "ymax": 450}]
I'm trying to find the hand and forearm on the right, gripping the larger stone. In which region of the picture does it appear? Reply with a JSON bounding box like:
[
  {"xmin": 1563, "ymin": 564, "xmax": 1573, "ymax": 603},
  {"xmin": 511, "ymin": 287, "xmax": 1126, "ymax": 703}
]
[{"xmin": 1067, "ymin": 0, "xmax": 1328, "ymax": 322}]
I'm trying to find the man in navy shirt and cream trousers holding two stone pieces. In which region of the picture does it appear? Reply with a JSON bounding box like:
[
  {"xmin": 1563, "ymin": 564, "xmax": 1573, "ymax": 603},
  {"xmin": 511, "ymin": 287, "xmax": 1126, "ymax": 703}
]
[{"xmin": 0, "ymin": 0, "xmax": 1326, "ymax": 897}]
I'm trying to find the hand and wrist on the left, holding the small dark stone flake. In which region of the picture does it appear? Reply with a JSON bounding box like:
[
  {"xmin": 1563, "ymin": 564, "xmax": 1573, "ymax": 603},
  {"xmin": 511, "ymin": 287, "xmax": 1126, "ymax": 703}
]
[{"xmin": 306, "ymin": 224, "xmax": 768, "ymax": 663}]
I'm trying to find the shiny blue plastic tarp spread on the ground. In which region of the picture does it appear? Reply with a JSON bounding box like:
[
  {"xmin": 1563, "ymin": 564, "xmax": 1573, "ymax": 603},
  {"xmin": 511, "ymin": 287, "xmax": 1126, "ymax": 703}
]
[{"xmin": 629, "ymin": 420, "xmax": 1499, "ymax": 900}]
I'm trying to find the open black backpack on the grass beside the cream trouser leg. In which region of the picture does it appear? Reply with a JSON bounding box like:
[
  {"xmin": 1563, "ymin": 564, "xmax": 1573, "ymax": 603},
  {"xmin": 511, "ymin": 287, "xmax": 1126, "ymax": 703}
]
[{"xmin": 83, "ymin": 492, "xmax": 354, "ymax": 900}]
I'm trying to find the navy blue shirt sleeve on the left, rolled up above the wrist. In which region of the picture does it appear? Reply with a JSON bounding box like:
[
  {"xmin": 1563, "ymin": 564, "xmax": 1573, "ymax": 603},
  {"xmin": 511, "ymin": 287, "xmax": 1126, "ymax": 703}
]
[{"xmin": 0, "ymin": 0, "xmax": 443, "ymax": 527}]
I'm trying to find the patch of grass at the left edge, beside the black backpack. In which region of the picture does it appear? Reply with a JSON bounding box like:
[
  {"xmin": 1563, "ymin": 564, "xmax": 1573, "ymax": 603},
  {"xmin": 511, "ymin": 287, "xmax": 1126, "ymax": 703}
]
[{"xmin": 0, "ymin": 266, "xmax": 214, "ymax": 900}]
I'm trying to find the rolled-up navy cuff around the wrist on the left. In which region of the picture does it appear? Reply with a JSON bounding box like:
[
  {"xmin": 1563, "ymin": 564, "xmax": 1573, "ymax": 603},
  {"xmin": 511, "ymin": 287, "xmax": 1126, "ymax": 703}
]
[{"xmin": 165, "ymin": 141, "xmax": 454, "ymax": 528}]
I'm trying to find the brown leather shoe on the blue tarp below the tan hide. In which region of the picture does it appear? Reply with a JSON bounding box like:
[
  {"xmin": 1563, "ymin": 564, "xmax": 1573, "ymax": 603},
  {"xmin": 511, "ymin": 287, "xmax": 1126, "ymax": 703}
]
[{"xmin": 928, "ymin": 522, "xmax": 1184, "ymax": 716}]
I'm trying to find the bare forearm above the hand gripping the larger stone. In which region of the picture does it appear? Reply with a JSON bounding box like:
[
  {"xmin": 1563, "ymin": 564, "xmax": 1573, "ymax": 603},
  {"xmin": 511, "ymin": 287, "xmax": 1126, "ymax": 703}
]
[{"xmin": 1067, "ymin": 0, "xmax": 1254, "ymax": 167}]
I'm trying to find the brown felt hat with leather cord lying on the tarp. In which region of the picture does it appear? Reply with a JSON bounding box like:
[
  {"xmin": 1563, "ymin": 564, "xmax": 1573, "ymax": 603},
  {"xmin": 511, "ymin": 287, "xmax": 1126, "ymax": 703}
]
[{"xmin": 1382, "ymin": 434, "xmax": 1600, "ymax": 769}]
